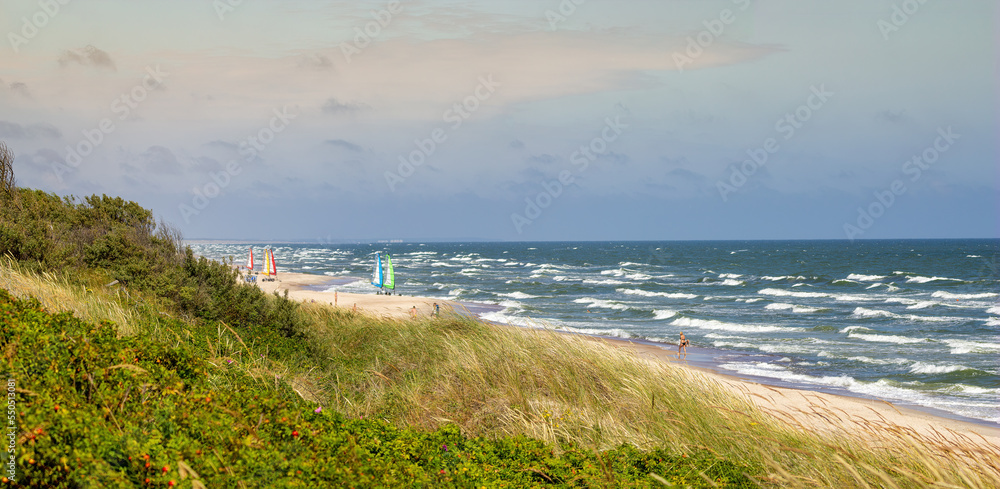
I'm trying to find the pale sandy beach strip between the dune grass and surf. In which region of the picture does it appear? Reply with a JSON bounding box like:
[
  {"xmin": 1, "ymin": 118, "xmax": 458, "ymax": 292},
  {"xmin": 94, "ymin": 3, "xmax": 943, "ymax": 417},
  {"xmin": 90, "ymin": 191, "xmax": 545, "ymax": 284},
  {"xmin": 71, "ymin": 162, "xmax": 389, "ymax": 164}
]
[{"xmin": 248, "ymin": 273, "xmax": 1000, "ymax": 447}]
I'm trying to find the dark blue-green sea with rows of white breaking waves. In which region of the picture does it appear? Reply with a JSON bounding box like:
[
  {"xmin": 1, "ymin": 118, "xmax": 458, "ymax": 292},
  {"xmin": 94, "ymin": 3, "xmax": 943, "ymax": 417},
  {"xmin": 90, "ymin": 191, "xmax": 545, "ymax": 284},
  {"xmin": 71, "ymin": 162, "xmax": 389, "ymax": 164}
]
[{"xmin": 191, "ymin": 240, "xmax": 1000, "ymax": 425}]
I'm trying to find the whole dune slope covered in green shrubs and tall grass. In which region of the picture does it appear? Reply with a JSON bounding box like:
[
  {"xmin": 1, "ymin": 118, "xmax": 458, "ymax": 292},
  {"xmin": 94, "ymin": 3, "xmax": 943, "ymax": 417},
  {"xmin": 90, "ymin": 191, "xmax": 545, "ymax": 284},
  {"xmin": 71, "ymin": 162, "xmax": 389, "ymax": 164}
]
[{"xmin": 0, "ymin": 186, "xmax": 1000, "ymax": 487}]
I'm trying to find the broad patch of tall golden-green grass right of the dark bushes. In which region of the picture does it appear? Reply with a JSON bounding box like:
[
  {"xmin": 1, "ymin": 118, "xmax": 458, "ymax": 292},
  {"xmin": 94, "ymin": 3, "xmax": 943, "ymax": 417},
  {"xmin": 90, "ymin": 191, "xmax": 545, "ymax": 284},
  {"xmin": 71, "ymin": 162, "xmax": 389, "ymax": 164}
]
[{"xmin": 304, "ymin": 306, "xmax": 1000, "ymax": 487}]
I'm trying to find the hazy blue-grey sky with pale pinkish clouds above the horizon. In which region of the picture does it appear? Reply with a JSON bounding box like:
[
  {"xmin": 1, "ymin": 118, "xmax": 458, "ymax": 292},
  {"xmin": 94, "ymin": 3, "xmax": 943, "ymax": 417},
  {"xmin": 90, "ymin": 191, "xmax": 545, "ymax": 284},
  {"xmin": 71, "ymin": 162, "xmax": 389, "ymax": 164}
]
[{"xmin": 0, "ymin": 0, "xmax": 1000, "ymax": 242}]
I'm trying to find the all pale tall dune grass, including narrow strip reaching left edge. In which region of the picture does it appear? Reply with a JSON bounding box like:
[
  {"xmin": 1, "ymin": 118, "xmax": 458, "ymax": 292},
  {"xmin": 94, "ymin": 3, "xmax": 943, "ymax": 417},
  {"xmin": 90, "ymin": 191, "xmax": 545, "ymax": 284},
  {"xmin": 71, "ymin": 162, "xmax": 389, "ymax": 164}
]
[{"xmin": 0, "ymin": 261, "xmax": 1000, "ymax": 487}]
